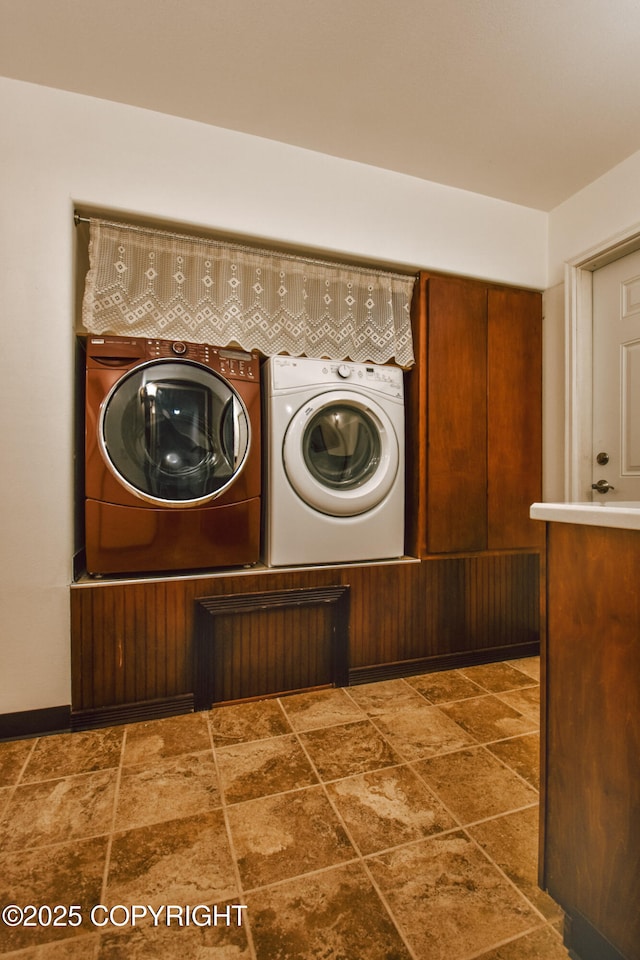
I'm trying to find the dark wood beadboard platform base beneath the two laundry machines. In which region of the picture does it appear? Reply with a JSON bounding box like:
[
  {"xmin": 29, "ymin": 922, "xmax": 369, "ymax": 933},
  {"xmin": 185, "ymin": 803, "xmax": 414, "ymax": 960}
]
[{"xmin": 71, "ymin": 552, "xmax": 541, "ymax": 725}]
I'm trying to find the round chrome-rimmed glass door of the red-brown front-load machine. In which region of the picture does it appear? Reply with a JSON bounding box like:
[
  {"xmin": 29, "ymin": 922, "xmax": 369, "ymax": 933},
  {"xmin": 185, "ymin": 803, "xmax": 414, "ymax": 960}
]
[{"xmin": 99, "ymin": 360, "xmax": 250, "ymax": 507}]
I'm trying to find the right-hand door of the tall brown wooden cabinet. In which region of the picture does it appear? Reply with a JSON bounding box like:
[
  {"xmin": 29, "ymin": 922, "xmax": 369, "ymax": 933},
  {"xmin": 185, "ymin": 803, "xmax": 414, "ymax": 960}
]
[{"xmin": 487, "ymin": 288, "xmax": 544, "ymax": 550}]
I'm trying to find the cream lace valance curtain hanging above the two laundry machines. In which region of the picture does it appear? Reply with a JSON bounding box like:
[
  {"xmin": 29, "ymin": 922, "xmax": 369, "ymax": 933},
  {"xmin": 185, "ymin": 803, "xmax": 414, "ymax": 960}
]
[{"xmin": 82, "ymin": 219, "xmax": 414, "ymax": 367}]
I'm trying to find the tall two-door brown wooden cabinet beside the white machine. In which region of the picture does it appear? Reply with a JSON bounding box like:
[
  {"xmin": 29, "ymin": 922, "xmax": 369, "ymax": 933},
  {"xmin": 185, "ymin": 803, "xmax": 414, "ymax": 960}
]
[{"xmin": 407, "ymin": 273, "xmax": 544, "ymax": 557}]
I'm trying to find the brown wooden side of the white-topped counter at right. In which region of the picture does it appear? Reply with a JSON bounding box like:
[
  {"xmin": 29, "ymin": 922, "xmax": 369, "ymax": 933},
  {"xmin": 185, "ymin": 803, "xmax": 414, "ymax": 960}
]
[{"xmin": 543, "ymin": 523, "xmax": 640, "ymax": 960}]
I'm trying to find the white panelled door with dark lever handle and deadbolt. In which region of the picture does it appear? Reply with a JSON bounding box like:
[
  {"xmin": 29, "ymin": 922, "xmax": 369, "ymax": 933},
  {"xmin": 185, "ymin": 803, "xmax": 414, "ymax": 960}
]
[{"xmin": 592, "ymin": 251, "xmax": 640, "ymax": 501}]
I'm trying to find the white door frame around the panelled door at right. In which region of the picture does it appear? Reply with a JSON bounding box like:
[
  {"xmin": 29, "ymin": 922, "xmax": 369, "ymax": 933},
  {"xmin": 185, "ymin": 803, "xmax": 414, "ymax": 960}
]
[{"xmin": 564, "ymin": 225, "xmax": 640, "ymax": 502}]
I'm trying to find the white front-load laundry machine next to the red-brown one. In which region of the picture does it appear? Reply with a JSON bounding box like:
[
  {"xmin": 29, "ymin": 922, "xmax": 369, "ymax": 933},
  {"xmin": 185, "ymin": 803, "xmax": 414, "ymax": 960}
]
[{"xmin": 263, "ymin": 356, "xmax": 404, "ymax": 567}]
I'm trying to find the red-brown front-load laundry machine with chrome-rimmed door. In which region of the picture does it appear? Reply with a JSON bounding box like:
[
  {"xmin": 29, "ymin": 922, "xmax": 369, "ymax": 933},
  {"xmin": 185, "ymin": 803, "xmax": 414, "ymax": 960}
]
[{"xmin": 85, "ymin": 336, "xmax": 261, "ymax": 575}]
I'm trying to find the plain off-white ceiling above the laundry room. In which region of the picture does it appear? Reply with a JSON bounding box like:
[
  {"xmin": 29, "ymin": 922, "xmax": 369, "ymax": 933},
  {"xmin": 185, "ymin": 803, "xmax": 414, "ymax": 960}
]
[{"xmin": 0, "ymin": 0, "xmax": 640, "ymax": 210}]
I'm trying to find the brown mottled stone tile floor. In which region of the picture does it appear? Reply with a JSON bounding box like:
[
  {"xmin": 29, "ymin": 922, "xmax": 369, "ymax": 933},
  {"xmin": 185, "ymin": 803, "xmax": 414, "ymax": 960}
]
[{"xmin": 0, "ymin": 658, "xmax": 568, "ymax": 960}]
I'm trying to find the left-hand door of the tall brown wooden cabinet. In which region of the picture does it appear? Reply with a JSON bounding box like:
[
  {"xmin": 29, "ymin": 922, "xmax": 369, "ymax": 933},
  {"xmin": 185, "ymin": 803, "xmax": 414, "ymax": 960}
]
[{"xmin": 426, "ymin": 277, "xmax": 487, "ymax": 553}]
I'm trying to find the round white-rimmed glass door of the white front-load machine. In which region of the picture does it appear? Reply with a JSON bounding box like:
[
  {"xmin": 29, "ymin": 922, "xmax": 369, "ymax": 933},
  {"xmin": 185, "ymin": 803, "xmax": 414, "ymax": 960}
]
[{"xmin": 283, "ymin": 390, "xmax": 399, "ymax": 517}]
